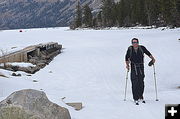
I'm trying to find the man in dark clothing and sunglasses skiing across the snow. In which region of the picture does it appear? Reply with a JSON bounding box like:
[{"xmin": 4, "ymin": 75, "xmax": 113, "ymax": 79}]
[{"xmin": 125, "ymin": 38, "xmax": 155, "ymax": 105}]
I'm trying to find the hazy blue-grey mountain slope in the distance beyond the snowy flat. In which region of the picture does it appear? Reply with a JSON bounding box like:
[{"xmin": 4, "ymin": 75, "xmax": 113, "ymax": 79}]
[{"xmin": 0, "ymin": 0, "xmax": 101, "ymax": 29}]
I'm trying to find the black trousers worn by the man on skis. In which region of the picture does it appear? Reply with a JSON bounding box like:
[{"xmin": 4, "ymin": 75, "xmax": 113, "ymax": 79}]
[{"xmin": 131, "ymin": 64, "xmax": 145, "ymax": 100}]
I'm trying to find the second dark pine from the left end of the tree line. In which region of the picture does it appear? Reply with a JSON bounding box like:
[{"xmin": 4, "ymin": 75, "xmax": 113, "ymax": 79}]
[{"xmin": 83, "ymin": 4, "xmax": 92, "ymax": 27}]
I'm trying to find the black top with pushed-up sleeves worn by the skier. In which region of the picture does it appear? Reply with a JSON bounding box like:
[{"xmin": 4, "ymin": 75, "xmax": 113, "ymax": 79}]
[{"xmin": 125, "ymin": 45, "xmax": 151, "ymax": 63}]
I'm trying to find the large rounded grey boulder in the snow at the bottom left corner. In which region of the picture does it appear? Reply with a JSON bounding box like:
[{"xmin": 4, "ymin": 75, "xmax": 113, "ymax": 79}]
[{"xmin": 0, "ymin": 89, "xmax": 71, "ymax": 119}]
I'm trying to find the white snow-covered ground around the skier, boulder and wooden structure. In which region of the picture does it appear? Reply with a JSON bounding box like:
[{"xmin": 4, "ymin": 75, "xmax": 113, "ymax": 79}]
[{"xmin": 0, "ymin": 28, "xmax": 180, "ymax": 119}]
